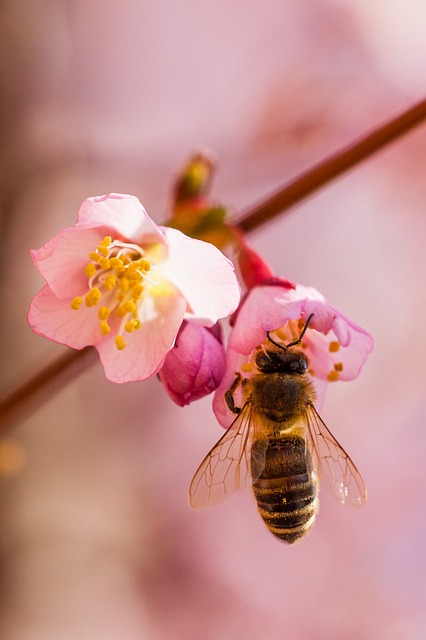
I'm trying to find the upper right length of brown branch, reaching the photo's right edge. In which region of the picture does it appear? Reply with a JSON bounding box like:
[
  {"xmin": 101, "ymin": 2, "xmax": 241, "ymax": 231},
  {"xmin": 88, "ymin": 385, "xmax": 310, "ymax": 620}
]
[{"xmin": 235, "ymin": 100, "xmax": 426, "ymax": 233}]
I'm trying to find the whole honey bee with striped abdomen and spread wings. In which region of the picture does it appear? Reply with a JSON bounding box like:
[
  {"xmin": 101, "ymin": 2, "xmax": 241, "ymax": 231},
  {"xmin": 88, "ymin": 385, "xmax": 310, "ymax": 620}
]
[{"xmin": 189, "ymin": 313, "xmax": 367, "ymax": 544}]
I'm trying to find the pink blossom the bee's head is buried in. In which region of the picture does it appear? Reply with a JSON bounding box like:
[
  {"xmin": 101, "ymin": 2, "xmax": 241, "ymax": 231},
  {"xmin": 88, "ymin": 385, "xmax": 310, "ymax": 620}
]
[{"xmin": 213, "ymin": 278, "xmax": 373, "ymax": 427}]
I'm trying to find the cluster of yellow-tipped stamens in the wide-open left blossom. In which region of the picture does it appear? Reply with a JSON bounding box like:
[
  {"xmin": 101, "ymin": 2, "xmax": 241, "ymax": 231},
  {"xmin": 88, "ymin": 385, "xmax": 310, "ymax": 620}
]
[{"xmin": 71, "ymin": 236, "xmax": 157, "ymax": 350}]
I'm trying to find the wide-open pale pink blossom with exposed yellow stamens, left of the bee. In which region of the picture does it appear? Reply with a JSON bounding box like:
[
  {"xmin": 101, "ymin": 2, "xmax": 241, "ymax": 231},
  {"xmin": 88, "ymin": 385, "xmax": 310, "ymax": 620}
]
[{"xmin": 28, "ymin": 194, "xmax": 239, "ymax": 383}]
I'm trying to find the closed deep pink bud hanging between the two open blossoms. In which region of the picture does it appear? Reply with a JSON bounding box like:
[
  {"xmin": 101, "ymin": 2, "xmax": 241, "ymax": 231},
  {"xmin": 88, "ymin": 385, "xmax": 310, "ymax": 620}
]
[{"xmin": 158, "ymin": 321, "xmax": 225, "ymax": 407}]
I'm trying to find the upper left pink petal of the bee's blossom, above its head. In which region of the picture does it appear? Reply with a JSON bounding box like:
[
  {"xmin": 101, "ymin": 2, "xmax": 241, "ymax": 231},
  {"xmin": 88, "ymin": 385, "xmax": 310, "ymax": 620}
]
[{"xmin": 229, "ymin": 286, "xmax": 303, "ymax": 355}]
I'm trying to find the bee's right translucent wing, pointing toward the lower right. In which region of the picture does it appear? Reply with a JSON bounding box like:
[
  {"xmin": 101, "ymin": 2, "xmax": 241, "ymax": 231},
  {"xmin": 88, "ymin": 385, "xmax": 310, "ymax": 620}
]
[{"xmin": 307, "ymin": 404, "xmax": 367, "ymax": 507}]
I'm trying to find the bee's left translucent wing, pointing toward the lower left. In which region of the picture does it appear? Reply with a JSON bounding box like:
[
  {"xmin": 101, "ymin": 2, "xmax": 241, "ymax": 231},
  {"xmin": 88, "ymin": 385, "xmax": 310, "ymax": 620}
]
[{"xmin": 189, "ymin": 402, "xmax": 265, "ymax": 509}]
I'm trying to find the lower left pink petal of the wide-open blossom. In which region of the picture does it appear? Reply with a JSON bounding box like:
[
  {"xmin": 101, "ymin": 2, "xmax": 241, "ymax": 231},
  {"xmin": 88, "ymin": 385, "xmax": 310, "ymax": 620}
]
[{"xmin": 28, "ymin": 285, "xmax": 103, "ymax": 349}]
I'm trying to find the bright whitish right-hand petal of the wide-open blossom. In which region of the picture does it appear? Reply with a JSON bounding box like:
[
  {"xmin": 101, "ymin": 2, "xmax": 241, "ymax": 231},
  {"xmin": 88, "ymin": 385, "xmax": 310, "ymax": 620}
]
[{"xmin": 161, "ymin": 227, "xmax": 240, "ymax": 325}]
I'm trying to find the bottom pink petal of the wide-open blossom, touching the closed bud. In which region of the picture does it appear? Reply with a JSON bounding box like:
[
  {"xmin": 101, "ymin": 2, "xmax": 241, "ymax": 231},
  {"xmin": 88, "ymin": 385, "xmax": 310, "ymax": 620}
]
[{"xmin": 95, "ymin": 296, "xmax": 186, "ymax": 384}]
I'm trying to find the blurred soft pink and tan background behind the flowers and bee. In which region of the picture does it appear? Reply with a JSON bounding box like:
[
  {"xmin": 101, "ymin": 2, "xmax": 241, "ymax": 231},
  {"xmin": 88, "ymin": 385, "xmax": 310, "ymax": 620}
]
[{"xmin": 0, "ymin": 0, "xmax": 426, "ymax": 640}]
